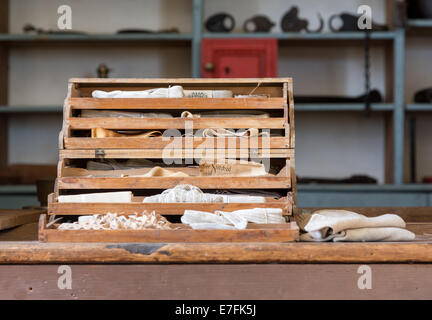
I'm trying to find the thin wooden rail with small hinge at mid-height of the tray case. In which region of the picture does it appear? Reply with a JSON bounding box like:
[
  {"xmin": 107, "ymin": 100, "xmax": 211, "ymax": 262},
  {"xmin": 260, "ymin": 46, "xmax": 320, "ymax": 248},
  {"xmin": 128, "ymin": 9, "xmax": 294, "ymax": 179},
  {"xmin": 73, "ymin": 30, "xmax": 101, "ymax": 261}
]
[{"xmin": 60, "ymin": 148, "xmax": 294, "ymax": 159}]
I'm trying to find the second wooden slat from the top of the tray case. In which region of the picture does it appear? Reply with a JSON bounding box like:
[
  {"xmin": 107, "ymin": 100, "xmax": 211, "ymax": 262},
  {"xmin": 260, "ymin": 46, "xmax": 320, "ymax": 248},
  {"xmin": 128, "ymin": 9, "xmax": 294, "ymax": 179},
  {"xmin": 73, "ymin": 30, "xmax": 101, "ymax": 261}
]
[{"xmin": 66, "ymin": 118, "xmax": 285, "ymax": 130}]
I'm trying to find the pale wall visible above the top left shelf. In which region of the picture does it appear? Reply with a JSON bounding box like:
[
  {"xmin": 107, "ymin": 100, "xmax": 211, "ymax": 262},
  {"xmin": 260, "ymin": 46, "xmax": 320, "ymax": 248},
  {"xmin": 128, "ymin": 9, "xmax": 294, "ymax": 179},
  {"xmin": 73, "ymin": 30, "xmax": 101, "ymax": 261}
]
[{"xmin": 9, "ymin": 0, "xmax": 192, "ymax": 33}]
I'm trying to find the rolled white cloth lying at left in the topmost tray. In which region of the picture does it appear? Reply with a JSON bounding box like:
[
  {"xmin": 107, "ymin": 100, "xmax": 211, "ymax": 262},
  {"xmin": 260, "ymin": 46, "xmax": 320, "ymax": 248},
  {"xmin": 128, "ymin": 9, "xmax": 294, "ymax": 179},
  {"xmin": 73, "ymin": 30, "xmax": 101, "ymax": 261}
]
[{"xmin": 92, "ymin": 86, "xmax": 184, "ymax": 98}]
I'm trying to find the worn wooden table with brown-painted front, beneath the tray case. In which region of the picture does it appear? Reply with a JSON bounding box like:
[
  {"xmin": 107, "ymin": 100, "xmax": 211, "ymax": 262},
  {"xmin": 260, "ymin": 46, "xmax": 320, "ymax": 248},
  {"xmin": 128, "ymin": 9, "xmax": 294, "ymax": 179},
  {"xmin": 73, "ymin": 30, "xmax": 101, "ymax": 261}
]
[{"xmin": 0, "ymin": 208, "xmax": 432, "ymax": 300}]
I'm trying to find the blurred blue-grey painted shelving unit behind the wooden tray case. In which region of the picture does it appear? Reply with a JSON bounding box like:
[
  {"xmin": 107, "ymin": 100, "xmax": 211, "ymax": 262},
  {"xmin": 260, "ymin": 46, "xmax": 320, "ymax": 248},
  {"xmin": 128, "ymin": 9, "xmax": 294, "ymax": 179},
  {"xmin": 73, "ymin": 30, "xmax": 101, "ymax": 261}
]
[{"xmin": 0, "ymin": 0, "xmax": 432, "ymax": 208}]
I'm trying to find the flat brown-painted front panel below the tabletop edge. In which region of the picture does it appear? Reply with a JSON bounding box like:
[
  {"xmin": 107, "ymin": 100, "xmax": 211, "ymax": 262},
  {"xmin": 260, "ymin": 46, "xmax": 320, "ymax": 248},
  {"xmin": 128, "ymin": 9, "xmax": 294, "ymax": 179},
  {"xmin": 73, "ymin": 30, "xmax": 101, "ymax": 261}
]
[{"xmin": 0, "ymin": 264, "xmax": 432, "ymax": 298}]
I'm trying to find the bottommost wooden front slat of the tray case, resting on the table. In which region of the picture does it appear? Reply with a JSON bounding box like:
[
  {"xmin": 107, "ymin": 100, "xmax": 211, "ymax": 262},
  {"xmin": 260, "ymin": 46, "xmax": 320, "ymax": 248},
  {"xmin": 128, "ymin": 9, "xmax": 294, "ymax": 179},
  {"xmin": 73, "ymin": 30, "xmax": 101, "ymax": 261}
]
[{"xmin": 39, "ymin": 215, "xmax": 299, "ymax": 243}]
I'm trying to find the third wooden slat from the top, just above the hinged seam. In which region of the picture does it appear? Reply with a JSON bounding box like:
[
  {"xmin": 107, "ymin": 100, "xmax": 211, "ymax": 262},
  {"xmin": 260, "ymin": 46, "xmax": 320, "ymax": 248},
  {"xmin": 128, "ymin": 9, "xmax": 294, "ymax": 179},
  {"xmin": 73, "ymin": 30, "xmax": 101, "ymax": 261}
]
[{"xmin": 64, "ymin": 137, "xmax": 289, "ymax": 149}]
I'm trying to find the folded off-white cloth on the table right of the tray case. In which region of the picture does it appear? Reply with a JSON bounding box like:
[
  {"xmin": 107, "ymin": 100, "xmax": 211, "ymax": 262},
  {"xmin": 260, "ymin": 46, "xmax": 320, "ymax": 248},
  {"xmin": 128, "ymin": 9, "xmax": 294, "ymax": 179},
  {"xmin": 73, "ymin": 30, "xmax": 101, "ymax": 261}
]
[{"xmin": 297, "ymin": 209, "xmax": 415, "ymax": 241}]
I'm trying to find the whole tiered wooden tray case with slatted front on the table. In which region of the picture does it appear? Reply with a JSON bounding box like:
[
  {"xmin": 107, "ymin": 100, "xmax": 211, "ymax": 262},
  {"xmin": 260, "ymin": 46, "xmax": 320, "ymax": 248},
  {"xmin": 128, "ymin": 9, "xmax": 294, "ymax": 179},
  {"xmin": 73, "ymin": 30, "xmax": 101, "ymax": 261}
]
[{"xmin": 39, "ymin": 78, "xmax": 298, "ymax": 242}]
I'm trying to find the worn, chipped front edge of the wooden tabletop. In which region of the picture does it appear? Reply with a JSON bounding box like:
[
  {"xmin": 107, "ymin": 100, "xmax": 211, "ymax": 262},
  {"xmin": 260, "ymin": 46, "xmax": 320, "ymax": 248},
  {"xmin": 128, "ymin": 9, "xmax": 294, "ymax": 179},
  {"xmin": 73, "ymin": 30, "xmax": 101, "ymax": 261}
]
[{"xmin": 0, "ymin": 241, "xmax": 432, "ymax": 264}]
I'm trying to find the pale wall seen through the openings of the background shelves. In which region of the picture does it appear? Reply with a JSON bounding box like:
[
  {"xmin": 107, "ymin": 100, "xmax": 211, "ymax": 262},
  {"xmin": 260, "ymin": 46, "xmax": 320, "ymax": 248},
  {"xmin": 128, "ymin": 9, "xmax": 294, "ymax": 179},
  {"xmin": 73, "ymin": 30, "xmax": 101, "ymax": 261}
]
[{"xmin": 5, "ymin": 0, "xmax": 394, "ymax": 182}]
